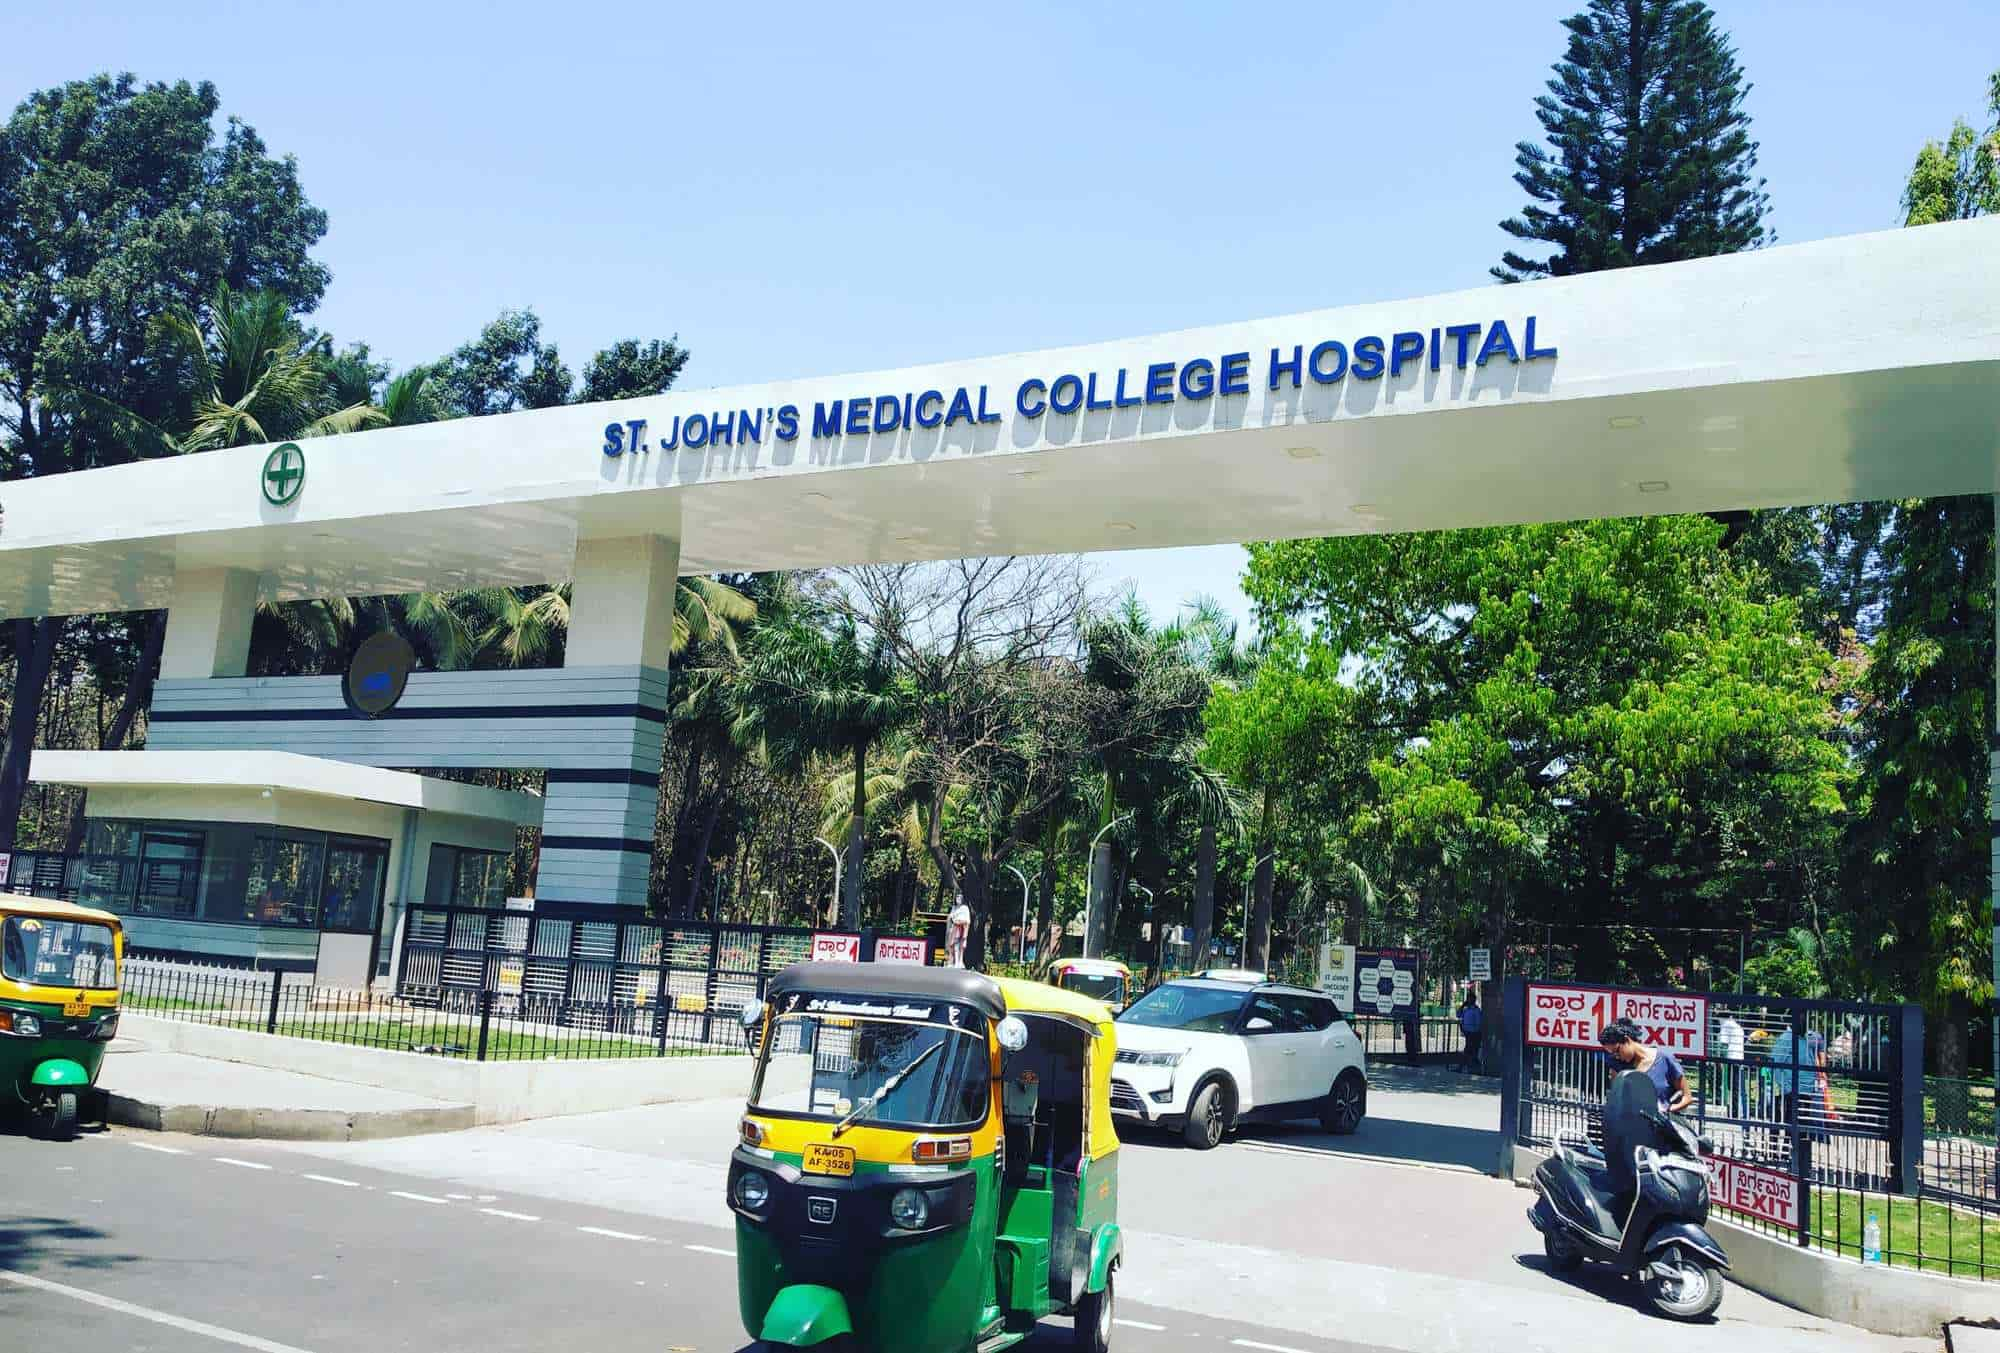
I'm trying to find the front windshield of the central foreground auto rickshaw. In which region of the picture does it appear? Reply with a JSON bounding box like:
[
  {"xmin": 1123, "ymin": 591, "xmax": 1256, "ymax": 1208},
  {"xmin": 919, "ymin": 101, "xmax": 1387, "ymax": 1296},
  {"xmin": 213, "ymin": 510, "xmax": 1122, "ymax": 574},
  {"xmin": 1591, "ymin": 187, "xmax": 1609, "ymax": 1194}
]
[{"xmin": 750, "ymin": 1007, "xmax": 992, "ymax": 1131}]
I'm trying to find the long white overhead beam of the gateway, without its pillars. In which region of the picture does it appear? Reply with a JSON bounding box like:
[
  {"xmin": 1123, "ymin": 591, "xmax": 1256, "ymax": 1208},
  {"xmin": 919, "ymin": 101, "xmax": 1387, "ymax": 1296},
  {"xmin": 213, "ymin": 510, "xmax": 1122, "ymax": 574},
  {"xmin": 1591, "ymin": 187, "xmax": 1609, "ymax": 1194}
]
[{"xmin": 0, "ymin": 220, "xmax": 2000, "ymax": 616}]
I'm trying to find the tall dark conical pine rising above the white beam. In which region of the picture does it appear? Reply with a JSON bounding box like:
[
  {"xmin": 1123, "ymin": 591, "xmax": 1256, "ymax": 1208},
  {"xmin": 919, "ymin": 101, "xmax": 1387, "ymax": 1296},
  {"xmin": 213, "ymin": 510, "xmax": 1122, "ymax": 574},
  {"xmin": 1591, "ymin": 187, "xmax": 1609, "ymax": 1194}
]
[{"xmin": 1492, "ymin": 0, "xmax": 1770, "ymax": 282}]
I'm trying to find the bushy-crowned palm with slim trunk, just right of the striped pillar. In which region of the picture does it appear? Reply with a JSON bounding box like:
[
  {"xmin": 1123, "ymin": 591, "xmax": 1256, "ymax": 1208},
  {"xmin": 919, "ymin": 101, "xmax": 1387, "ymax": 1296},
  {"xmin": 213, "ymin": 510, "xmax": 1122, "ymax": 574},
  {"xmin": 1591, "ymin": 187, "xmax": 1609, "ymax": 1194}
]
[{"xmin": 736, "ymin": 608, "xmax": 912, "ymax": 931}]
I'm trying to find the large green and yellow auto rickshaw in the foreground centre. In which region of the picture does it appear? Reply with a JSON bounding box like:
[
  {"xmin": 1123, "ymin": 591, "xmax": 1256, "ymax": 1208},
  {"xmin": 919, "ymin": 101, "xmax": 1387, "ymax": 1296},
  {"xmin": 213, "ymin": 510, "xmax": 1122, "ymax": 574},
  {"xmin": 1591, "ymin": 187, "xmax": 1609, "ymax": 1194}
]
[{"xmin": 728, "ymin": 963, "xmax": 1124, "ymax": 1353}]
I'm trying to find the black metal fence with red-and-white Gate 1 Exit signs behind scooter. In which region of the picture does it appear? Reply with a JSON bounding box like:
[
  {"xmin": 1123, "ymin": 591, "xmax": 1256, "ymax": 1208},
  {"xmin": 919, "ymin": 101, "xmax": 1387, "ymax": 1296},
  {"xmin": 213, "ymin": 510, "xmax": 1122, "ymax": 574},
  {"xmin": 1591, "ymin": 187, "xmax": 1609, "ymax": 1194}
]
[{"xmin": 1502, "ymin": 979, "xmax": 2000, "ymax": 1279}]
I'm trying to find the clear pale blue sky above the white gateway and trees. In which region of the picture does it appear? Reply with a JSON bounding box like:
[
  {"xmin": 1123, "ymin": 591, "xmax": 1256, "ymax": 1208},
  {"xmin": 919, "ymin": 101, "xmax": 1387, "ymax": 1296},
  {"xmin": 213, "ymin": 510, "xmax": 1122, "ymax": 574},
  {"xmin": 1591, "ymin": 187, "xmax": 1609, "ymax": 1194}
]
[{"xmin": 0, "ymin": 0, "xmax": 2000, "ymax": 632}]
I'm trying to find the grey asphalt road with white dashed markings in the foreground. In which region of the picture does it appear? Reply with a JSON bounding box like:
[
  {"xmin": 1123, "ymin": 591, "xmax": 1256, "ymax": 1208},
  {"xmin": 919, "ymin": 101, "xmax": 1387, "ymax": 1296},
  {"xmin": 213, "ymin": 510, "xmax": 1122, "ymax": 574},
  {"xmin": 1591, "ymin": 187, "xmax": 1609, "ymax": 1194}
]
[{"xmin": 0, "ymin": 1131, "xmax": 1380, "ymax": 1353}]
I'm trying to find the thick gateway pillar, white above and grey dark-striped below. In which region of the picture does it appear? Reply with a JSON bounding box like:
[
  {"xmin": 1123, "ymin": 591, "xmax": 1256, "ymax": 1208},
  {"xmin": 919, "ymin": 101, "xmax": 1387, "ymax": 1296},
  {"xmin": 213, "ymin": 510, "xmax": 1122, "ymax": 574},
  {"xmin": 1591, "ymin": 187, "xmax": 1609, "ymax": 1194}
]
[{"xmin": 534, "ymin": 536, "xmax": 680, "ymax": 907}]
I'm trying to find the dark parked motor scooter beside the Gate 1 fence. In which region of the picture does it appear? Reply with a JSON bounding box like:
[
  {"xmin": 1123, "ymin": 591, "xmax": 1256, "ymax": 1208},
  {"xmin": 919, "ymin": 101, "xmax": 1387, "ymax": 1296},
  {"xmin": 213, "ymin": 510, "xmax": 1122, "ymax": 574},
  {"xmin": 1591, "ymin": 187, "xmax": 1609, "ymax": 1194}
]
[{"xmin": 1528, "ymin": 1071, "xmax": 1730, "ymax": 1321}]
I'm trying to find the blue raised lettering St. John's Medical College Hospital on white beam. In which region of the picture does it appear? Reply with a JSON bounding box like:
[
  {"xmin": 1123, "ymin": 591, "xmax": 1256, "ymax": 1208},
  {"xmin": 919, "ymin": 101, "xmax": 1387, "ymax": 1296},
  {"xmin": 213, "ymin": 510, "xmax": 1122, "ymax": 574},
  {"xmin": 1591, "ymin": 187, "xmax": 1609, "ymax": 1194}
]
[{"xmin": 584, "ymin": 314, "xmax": 1558, "ymax": 458}]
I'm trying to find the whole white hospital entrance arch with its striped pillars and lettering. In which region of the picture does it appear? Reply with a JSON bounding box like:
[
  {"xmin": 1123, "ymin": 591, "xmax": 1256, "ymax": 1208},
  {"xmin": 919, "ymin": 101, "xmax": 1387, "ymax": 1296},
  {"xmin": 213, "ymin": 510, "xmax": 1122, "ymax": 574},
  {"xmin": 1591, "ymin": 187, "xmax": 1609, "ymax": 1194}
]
[{"xmin": 0, "ymin": 220, "xmax": 2000, "ymax": 984}]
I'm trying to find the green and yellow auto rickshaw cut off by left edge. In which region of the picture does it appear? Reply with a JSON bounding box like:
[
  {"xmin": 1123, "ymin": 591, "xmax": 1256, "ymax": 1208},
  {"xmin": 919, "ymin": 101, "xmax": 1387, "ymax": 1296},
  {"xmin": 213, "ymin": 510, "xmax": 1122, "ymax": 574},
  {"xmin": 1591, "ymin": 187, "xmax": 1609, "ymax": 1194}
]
[{"xmin": 0, "ymin": 893, "xmax": 124, "ymax": 1141}]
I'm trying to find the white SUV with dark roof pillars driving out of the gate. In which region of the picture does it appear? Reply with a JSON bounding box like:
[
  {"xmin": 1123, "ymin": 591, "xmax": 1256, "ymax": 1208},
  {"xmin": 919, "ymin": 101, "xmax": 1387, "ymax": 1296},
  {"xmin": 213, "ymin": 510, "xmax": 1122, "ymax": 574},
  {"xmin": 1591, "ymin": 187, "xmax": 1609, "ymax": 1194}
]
[{"xmin": 1112, "ymin": 977, "xmax": 1368, "ymax": 1151}]
